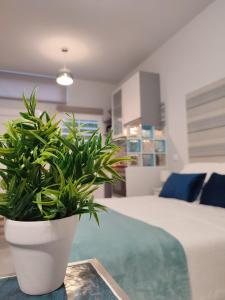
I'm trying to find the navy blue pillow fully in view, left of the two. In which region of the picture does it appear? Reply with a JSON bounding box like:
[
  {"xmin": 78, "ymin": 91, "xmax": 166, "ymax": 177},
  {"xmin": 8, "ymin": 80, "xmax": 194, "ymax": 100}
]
[{"xmin": 159, "ymin": 173, "xmax": 206, "ymax": 202}]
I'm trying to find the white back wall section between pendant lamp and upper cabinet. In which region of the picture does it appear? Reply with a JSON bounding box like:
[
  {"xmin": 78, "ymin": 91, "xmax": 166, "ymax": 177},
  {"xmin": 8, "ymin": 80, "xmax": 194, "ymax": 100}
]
[{"xmin": 67, "ymin": 79, "xmax": 115, "ymax": 116}]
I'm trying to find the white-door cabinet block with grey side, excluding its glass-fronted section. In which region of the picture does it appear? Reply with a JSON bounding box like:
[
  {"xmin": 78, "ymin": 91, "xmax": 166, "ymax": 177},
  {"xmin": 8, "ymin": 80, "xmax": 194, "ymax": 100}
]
[{"xmin": 122, "ymin": 71, "xmax": 160, "ymax": 127}]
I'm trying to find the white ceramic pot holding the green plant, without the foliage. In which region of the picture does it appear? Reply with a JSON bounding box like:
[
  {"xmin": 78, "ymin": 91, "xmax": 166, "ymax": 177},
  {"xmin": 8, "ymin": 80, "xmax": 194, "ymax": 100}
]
[{"xmin": 5, "ymin": 216, "xmax": 78, "ymax": 295}]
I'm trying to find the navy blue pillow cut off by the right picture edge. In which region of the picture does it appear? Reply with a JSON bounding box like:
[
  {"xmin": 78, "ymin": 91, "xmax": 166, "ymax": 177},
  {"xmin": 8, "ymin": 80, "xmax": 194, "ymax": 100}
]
[{"xmin": 200, "ymin": 173, "xmax": 225, "ymax": 208}]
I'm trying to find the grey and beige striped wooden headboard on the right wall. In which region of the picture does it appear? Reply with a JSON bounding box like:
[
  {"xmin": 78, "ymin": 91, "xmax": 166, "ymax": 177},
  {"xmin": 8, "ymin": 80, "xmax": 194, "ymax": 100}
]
[{"xmin": 186, "ymin": 79, "xmax": 225, "ymax": 162}]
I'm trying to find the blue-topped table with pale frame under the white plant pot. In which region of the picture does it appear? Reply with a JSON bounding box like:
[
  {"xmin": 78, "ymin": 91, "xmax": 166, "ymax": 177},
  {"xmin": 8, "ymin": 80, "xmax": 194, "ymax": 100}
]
[{"xmin": 0, "ymin": 259, "xmax": 129, "ymax": 300}]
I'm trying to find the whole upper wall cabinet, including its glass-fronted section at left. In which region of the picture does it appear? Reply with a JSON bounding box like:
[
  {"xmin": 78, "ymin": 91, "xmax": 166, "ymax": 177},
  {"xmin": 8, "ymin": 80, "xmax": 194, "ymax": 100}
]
[{"xmin": 112, "ymin": 71, "xmax": 161, "ymax": 138}]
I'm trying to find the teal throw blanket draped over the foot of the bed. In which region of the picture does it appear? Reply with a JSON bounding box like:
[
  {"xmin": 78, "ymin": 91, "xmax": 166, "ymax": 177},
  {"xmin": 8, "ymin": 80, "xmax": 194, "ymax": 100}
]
[{"xmin": 70, "ymin": 210, "xmax": 191, "ymax": 300}]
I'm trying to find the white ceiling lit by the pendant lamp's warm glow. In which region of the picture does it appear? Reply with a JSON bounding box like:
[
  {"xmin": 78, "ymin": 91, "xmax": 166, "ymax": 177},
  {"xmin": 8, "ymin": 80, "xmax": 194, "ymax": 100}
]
[{"xmin": 0, "ymin": 0, "xmax": 213, "ymax": 83}]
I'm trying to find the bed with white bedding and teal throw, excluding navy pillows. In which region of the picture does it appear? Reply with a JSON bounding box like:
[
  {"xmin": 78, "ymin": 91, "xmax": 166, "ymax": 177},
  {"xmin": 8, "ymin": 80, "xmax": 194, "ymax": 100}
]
[{"xmin": 71, "ymin": 164, "xmax": 225, "ymax": 300}]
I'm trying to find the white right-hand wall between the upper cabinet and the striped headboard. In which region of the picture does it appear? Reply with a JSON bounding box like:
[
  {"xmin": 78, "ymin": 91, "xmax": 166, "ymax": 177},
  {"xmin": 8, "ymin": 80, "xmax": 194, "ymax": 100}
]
[{"xmin": 125, "ymin": 0, "xmax": 225, "ymax": 170}]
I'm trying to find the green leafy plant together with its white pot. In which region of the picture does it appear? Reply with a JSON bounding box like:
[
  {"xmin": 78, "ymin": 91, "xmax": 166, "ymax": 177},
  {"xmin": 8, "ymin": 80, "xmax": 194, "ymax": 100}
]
[{"xmin": 0, "ymin": 92, "xmax": 127, "ymax": 295}]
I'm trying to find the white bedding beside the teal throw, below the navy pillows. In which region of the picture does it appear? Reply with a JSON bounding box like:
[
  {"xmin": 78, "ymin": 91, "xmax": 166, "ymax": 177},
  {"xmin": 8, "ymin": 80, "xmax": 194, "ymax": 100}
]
[{"xmin": 98, "ymin": 196, "xmax": 225, "ymax": 300}]
